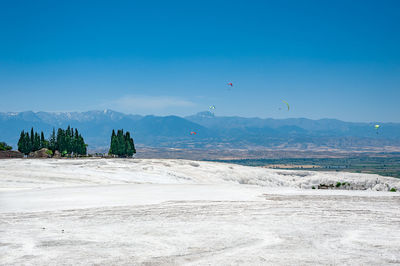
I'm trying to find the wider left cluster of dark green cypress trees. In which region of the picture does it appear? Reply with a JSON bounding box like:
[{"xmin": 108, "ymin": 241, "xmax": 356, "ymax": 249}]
[{"xmin": 18, "ymin": 126, "xmax": 87, "ymax": 156}]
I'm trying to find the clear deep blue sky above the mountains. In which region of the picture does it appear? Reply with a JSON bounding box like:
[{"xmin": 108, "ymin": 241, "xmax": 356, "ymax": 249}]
[{"xmin": 0, "ymin": 0, "xmax": 400, "ymax": 122}]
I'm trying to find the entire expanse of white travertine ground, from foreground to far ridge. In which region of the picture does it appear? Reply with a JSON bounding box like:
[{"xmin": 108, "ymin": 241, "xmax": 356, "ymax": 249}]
[{"xmin": 0, "ymin": 159, "xmax": 400, "ymax": 265}]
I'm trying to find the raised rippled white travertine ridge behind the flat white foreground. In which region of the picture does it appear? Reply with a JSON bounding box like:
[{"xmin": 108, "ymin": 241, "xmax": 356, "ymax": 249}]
[{"xmin": 0, "ymin": 159, "xmax": 400, "ymax": 191}]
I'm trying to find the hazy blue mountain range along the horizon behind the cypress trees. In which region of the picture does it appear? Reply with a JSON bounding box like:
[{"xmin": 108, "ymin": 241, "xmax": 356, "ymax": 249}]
[{"xmin": 0, "ymin": 110, "xmax": 400, "ymax": 151}]
